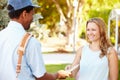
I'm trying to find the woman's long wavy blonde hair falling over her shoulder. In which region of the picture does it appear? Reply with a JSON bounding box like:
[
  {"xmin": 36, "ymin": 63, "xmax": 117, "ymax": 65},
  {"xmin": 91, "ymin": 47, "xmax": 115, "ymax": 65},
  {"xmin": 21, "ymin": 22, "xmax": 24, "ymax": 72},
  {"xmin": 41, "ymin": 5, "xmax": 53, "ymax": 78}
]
[{"xmin": 86, "ymin": 18, "xmax": 112, "ymax": 57}]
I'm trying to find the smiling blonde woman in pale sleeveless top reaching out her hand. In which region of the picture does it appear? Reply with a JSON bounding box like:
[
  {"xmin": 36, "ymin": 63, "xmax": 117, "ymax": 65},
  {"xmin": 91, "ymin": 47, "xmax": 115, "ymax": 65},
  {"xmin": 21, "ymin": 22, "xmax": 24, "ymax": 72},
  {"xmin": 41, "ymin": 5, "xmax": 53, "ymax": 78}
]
[{"xmin": 66, "ymin": 18, "xmax": 118, "ymax": 80}]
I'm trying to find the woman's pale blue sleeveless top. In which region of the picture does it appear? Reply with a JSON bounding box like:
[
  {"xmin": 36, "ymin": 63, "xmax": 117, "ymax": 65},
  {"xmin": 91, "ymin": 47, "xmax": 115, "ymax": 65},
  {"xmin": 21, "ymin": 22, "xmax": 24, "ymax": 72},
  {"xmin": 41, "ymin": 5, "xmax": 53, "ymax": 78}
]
[{"xmin": 78, "ymin": 45, "xmax": 109, "ymax": 80}]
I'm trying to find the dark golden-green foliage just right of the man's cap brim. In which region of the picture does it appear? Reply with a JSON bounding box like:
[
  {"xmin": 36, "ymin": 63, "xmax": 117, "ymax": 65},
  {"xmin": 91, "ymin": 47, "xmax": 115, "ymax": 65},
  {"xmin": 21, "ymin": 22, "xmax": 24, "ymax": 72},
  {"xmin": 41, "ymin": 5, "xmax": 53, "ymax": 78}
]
[{"xmin": 36, "ymin": 0, "xmax": 59, "ymax": 25}]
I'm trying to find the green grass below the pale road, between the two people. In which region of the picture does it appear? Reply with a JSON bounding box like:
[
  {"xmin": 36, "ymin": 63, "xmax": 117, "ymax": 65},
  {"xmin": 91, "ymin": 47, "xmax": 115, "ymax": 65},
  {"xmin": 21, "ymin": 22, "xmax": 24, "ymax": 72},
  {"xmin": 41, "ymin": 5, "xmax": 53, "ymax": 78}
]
[{"xmin": 46, "ymin": 60, "xmax": 120, "ymax": 80}]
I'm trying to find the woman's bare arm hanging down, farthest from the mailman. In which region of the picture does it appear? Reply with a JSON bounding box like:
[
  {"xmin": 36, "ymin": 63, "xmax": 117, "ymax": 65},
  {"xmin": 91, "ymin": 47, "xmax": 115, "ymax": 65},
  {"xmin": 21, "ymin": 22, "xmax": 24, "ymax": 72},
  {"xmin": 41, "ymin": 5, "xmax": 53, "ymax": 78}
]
[{"xmin": 108, "ymin": 48, "xmax": 118, "ymax": 80}]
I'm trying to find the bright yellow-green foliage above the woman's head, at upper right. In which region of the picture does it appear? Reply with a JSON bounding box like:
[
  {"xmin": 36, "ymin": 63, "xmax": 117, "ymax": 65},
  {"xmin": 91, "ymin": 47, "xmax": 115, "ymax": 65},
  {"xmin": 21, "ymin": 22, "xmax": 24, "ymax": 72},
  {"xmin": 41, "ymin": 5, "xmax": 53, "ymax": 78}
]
[{"xmin": 83, "ymin": 0, "xmax": 120, "ymax": 23}]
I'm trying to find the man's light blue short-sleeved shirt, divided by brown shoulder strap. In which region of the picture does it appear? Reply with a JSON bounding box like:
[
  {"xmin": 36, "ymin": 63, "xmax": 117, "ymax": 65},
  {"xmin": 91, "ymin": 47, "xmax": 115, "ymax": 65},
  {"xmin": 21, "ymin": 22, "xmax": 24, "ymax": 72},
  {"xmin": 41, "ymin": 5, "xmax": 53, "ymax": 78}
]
[{"xmin": 0, "ymin": 21, "xmax": 46, "ymax": 80}]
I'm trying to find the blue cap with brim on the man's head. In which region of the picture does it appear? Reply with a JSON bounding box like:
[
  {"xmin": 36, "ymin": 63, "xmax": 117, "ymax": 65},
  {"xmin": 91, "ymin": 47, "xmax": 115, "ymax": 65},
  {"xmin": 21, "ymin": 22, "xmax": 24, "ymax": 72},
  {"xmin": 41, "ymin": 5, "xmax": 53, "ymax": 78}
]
[{"xmin": 8, "ymin": 0, "xmax": 40, "ymax": 10}]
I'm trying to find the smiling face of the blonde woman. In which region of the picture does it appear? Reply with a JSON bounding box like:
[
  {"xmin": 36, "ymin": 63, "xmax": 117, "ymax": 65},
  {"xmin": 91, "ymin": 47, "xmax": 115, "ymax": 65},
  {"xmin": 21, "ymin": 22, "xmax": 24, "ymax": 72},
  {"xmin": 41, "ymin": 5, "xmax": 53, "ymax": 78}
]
[{"xmin": 86, "ymin": 22, "xmax": 100, "ymax": 42}]
